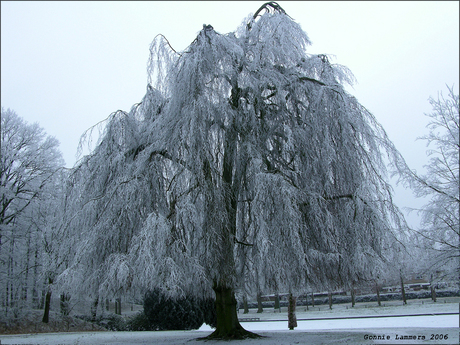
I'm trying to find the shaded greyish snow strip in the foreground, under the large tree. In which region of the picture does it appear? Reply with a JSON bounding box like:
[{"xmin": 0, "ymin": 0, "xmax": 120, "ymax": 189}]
[{"xmin": 1, "ymin": 320, "xmax": 459, "ymax": 345}]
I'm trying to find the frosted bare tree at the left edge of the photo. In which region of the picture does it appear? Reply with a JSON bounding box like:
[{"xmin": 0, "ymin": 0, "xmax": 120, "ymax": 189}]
[{"xmin": 0, "ymin": 108, "xmax": 63, "ymax": 317}]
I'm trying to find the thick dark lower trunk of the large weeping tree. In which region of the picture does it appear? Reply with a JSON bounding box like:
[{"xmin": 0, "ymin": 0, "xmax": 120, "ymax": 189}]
[{"xmin": 205, "ymin": 285, "xmax": 260, "ymax": 340}]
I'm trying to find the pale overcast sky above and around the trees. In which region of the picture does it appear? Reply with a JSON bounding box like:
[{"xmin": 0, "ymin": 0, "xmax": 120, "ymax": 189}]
[{"xmin": 1, "ymin": 1, "xmax": 459, "ymax": 228}]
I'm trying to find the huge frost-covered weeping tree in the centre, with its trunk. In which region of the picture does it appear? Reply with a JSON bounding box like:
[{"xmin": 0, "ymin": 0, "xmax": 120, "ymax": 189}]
[{"xmin": 61, "ymin": 2, "xmax": 402, "ymax": 339}]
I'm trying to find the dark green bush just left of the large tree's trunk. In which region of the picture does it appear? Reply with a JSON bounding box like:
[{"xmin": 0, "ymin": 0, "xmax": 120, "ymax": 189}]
[{"xmin": 144, "ymin": 290, "xmax": 216, "ymax": 331}]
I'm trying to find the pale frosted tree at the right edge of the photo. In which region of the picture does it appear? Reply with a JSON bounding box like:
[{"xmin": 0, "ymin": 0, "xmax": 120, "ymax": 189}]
[{"xmin": 400, "ymin": 87, "xmax": 460, "ymax": 280}]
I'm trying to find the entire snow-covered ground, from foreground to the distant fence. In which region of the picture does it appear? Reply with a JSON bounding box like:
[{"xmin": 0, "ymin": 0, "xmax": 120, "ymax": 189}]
[{"xmin": 0, "ymin": 298, "xmax": 460, "ymax": 345}]
